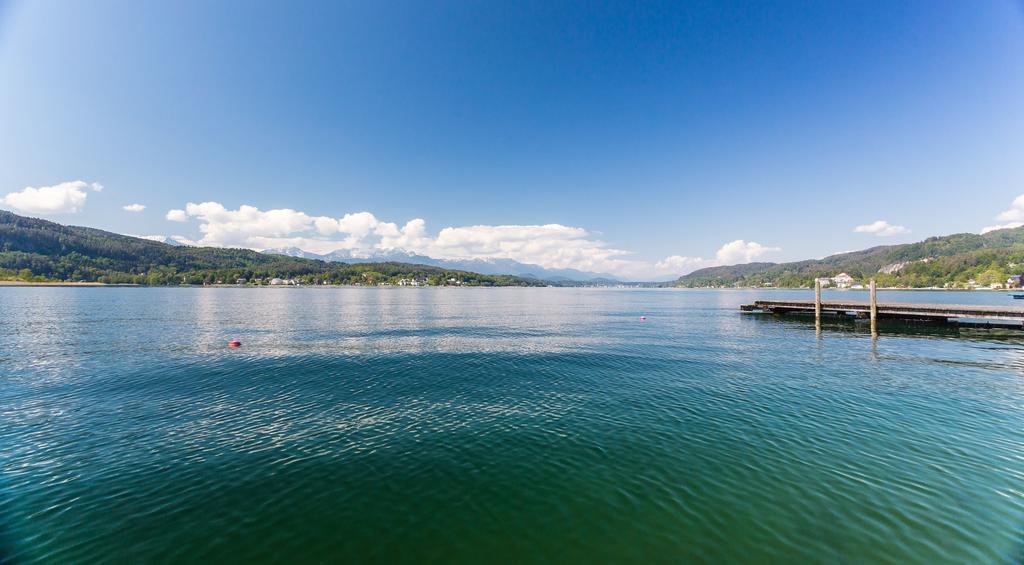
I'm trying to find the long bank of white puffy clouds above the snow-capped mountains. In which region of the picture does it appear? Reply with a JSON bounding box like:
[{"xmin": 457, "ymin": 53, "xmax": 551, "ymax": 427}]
[{"xmin": 167, "ymin": 202, "xmax": 779, "ymax": 278}]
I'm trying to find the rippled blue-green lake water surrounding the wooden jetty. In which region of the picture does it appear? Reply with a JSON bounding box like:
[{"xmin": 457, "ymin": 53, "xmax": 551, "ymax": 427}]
[{"xmin": 0, "ymin": 288, "xmax": 1024, "ymax": 563}]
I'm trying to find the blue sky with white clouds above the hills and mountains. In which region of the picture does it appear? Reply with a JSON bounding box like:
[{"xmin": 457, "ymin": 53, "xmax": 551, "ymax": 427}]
[{"xmin": 0, "ymin": 0, "xmax": 1024, "ymax": 278}]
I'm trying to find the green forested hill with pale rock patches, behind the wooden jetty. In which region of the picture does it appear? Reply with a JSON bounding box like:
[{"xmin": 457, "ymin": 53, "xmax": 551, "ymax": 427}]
[{"xmin": 675, "ymin": 228, "xmax": 1024, "ymax": 288}]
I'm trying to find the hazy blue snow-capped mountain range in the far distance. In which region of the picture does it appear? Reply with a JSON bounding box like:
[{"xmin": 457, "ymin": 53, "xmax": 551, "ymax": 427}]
[{"xmin": 263, "ymin": 248, "xmax": 621, "ymax": 284}]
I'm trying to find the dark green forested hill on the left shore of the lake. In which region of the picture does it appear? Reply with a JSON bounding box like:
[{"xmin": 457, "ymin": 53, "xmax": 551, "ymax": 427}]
[{"xmin": 0, "ymin": 211, "xmax": 541, "ymax": 286}]
